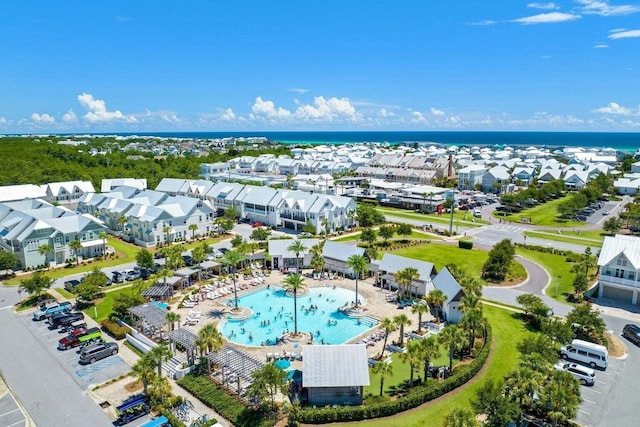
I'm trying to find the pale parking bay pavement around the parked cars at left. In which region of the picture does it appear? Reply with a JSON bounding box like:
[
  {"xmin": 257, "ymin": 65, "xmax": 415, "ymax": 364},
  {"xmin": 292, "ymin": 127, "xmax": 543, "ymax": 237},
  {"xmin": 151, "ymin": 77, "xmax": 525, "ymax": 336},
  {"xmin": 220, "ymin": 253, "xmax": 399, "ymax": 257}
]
[{"xmin": 20, "ymin": 316, "xmax": 131, "ymax": 389}]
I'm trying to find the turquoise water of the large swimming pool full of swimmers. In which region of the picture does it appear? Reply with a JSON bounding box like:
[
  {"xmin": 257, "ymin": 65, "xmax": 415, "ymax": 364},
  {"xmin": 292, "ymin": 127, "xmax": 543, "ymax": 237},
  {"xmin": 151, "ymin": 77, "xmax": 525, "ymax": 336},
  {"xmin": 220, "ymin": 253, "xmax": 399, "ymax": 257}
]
[{"xmin": 219, "ymin": 287, "xmax": 378, "ymax": 346}]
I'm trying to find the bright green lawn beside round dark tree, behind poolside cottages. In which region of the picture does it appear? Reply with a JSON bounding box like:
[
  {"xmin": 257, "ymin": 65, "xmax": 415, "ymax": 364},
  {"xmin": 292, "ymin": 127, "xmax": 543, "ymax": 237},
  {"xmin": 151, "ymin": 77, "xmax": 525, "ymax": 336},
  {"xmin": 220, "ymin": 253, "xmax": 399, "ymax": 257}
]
[{"xmin": 390, "ymin": 244, "xmax": 527, "ymax": 284}]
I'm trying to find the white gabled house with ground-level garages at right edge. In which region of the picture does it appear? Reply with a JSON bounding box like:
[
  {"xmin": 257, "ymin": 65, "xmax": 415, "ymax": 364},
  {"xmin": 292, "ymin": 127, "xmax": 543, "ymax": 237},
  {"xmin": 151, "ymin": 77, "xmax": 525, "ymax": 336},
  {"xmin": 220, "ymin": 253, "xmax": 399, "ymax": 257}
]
[{"xmin": 598, "ymin": 234, "xmax": 640, "ymax": 304}]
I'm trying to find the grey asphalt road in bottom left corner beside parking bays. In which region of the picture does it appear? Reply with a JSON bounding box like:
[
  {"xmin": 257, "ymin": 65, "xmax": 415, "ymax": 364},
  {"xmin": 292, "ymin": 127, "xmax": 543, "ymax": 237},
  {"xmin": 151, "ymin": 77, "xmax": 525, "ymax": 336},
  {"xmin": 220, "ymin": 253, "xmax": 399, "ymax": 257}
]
[{"xmin": 0, "ymin": 286, "xmax": 112, "ymax": 427}]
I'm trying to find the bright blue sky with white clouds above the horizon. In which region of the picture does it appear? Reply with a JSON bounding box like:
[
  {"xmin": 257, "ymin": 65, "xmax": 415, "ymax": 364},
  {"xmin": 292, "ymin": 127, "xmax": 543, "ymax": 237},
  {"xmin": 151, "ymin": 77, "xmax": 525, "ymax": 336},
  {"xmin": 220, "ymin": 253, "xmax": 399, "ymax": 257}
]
[{"xmin": 0, "ymin": 0, "xmax": 640, "ymax": 133}]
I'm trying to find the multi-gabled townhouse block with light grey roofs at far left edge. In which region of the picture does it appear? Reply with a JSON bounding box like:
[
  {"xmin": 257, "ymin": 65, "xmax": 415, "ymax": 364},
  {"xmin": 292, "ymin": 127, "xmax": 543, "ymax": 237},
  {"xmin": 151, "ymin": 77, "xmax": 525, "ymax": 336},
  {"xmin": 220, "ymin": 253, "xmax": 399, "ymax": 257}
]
[{"xmin": 0, "ymin": 199, "xmax": 106, "ymax": 269}]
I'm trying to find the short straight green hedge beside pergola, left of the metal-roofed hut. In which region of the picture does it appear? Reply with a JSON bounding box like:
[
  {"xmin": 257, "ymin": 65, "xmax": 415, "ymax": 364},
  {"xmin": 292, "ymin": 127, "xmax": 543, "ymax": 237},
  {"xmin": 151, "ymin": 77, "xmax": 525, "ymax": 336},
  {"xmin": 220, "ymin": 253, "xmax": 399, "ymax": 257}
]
[{"xmin": 178, "ymin": 374, "xmax": 273, "ymax": 427}]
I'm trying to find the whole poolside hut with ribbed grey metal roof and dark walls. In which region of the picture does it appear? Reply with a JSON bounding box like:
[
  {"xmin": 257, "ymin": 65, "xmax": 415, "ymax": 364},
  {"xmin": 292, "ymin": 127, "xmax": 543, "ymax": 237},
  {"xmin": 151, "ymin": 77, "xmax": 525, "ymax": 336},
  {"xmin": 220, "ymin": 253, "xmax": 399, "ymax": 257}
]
[{"xmin": 302, "ymin": 344, "xmax": 370, "ymax": 406}]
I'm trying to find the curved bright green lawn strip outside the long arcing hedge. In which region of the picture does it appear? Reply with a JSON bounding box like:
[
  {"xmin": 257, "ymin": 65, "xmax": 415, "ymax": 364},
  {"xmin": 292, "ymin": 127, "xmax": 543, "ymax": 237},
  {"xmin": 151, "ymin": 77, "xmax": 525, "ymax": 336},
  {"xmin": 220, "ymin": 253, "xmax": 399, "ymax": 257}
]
[{"xmin": 334, "ymin": 305, "xmax": 530, "ymax": 427}]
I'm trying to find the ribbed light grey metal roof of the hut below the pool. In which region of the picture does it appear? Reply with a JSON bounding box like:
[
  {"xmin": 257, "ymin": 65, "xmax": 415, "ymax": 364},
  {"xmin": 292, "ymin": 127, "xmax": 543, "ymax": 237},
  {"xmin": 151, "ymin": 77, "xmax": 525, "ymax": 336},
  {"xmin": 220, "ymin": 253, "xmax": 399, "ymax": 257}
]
[{"xmin": 302, "ymin": 344, "xmax": 369, "ymax": 387}]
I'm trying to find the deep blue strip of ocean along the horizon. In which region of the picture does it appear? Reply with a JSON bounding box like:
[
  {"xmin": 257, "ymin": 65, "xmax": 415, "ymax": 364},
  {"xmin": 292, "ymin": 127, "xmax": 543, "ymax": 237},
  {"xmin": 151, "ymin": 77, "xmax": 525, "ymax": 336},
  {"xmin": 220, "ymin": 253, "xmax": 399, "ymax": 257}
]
[{"xmin": 110, "ymin": 131, "xmax": 640, "ymax": 152}]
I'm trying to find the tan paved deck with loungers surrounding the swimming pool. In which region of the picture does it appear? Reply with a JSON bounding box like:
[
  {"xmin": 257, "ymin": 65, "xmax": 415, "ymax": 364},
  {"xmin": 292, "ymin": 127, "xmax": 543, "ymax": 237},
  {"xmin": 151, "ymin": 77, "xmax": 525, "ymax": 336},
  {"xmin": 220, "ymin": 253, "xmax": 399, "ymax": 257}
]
[{"xmin": 171, "ymin": 269, "xmax": 432, "ymax": 369}]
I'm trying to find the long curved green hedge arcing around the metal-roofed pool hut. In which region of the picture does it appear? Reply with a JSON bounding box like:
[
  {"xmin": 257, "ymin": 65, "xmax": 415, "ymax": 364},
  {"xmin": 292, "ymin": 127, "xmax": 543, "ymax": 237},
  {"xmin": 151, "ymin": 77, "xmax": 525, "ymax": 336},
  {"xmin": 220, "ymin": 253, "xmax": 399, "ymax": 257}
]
[{"xmin": 292, "ymin": 326, "xmax": 492, "ymax": 424}]
